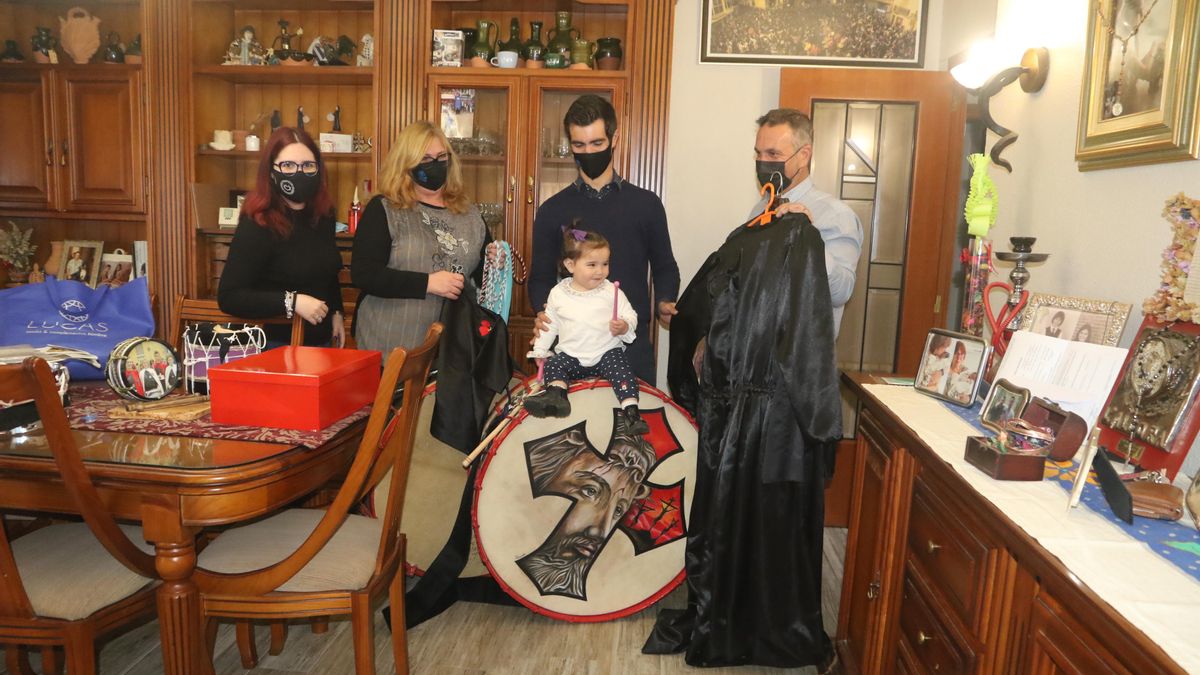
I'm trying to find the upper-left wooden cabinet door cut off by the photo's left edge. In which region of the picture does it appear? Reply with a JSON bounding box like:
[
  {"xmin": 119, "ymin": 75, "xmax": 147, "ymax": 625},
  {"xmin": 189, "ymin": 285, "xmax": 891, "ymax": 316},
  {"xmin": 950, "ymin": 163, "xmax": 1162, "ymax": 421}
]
[{"xmin": 0, "ymin": 67, "xmax": 58, "ymax": 211}]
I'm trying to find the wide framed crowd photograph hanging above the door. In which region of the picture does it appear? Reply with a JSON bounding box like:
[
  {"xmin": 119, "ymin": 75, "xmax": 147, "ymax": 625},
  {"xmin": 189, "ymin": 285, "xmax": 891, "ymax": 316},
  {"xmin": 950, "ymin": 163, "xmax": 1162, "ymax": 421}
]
[{"xmin": 700, "ymin": 0, "xmax": 929, "ymax": 68}]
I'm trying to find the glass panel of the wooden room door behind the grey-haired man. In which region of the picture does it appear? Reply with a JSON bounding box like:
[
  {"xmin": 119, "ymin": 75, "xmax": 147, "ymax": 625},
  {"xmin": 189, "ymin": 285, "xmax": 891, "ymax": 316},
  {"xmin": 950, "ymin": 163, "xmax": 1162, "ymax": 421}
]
[{"xmin": 812, "ymin": 101, "xmax": 917, "ymax": 437}]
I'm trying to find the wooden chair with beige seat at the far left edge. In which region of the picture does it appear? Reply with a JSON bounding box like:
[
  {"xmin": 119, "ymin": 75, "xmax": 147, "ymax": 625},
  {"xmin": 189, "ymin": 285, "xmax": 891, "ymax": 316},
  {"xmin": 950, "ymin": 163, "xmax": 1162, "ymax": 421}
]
[{"xmin": 0, "ymin": 358, "xmax": 155, "ymax": 675}]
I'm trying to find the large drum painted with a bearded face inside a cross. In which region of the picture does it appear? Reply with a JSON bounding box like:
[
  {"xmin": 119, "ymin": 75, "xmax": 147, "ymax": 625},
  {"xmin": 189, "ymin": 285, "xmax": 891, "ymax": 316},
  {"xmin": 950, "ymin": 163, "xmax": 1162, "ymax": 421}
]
[{"xmin": 473, "ymin": 381, "xmax": 697, "ymax": 621}]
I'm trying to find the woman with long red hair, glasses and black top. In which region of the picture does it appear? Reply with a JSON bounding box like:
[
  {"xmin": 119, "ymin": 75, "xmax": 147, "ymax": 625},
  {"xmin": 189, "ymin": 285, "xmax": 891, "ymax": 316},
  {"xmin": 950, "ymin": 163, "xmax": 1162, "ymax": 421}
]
[{"xmin": 217, "ymin": 127, "xmax": 346, "ymax": 347}]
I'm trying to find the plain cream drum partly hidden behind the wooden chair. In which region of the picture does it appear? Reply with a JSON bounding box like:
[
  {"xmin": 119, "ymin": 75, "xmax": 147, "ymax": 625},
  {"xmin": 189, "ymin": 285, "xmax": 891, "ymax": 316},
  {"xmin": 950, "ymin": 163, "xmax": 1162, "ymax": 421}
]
[{"xmin": 370, "ymin": 378, "xmax": 521, "ymax": 577}]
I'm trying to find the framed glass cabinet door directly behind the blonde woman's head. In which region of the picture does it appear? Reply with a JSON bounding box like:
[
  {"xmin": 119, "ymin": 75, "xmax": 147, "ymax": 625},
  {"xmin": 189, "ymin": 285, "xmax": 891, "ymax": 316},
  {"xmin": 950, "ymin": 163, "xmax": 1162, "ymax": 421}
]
[{"xmin": 430, "ymin": 76, "xmax": 520, "ymax": 239}]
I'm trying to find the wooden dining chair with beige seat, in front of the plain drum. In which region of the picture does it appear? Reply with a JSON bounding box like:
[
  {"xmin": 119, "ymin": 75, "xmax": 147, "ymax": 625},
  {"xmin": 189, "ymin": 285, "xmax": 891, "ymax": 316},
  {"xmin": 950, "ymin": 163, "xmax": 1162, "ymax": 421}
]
[{"xmin": 196, "ymin": 323, "xmax": 442, "ymax": 675}]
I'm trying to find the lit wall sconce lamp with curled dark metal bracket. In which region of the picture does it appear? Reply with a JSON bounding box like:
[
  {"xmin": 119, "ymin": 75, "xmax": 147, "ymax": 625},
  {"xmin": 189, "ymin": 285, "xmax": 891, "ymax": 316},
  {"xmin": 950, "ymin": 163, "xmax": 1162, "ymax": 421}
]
[{"xmin": 950, "ymin": 42, "xmax": 1050, "ymax": 173}]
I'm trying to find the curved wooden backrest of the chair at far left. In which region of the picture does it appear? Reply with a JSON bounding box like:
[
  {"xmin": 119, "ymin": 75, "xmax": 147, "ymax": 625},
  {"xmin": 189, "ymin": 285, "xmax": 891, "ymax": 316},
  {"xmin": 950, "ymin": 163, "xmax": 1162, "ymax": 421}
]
[{"xmin": 0, "ymin": 357, "xmax": 155, "ymax": 616}]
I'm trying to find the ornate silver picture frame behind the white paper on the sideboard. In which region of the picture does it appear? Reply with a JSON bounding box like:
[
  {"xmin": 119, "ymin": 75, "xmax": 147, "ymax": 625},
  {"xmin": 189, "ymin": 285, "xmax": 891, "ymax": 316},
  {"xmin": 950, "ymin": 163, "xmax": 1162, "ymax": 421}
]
[{"xmin": 1021, "ymin": 293, "xmax": 1133, "ymax": 347}]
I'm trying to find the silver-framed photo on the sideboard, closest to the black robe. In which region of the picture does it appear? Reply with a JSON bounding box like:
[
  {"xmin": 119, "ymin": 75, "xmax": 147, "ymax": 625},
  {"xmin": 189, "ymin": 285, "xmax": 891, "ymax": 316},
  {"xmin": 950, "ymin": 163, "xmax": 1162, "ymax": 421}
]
[{"xmin": 913, "ymin": 328, "xmax": 991, "ymax": 407}]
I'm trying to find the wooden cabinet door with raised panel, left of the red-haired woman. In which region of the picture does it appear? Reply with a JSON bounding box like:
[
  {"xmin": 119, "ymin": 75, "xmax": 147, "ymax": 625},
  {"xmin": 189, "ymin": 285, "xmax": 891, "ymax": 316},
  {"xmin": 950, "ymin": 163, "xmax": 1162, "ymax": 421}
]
[{"xmin": 58, "ymin": 66, "xmax": 145, "ymax": 214}]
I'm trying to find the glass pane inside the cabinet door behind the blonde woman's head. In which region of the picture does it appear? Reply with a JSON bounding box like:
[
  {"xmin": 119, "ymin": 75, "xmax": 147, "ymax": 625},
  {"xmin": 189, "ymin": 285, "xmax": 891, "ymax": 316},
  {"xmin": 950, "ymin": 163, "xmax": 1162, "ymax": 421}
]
[{"xmin": 438, "ymin": 86, "xmax": 509, "ymax": 239}]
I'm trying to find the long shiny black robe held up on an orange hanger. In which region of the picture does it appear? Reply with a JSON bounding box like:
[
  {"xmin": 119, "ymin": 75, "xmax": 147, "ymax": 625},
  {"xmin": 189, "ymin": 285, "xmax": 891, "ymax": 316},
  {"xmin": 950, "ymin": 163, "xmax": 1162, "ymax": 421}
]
[{"xmin": 643, "ymin": 214, "xmax": 841, "ymax": 667}]
